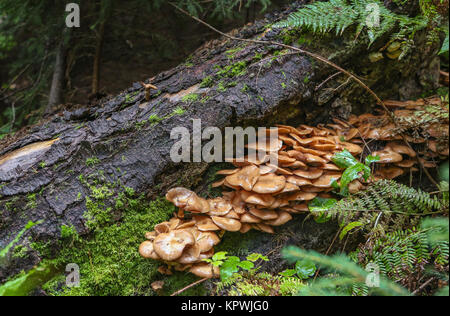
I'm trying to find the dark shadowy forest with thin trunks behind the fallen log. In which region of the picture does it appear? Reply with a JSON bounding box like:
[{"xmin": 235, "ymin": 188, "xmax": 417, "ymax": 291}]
[{"xmin": 0, "ymin": 0, "xmax": 289, "ymax": 138}]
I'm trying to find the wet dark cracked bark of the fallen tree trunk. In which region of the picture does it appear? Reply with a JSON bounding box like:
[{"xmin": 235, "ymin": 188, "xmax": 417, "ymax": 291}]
[{"xmin": 0, "ymin": 1, "xmax": 438, "ymax": 281}]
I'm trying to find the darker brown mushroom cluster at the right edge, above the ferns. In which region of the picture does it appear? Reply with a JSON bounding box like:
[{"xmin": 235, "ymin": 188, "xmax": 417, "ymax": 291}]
[{"xmin": 348, "ymin": 98, "xmax": 449, "ymax": 179}]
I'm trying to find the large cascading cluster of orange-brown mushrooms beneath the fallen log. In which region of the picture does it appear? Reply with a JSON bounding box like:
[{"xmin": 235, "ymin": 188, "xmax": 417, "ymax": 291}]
[{"xmin": 139, "ymin": 106, "xmax": 448, "ymax": 278}]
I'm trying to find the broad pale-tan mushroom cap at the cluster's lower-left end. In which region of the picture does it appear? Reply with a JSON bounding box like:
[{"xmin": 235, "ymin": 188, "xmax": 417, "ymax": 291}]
[{"xmin": 153, "ymin": 230, "xmax": 195, "ymax": 261}]
